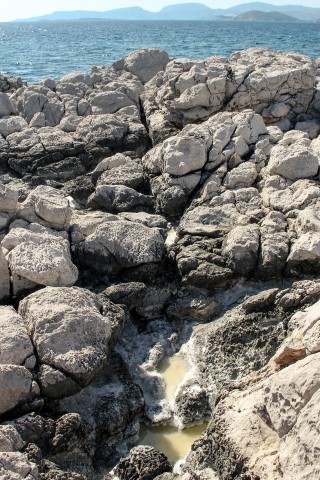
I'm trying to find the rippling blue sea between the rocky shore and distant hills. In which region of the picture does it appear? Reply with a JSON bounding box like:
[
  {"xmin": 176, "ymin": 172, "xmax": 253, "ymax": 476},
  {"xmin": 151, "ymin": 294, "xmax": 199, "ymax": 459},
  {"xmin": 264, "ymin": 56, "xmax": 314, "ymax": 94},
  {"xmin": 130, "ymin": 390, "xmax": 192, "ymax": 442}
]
[{"xmin": 0, "ymin": 20, "xmax": 320, "ymax": 83}]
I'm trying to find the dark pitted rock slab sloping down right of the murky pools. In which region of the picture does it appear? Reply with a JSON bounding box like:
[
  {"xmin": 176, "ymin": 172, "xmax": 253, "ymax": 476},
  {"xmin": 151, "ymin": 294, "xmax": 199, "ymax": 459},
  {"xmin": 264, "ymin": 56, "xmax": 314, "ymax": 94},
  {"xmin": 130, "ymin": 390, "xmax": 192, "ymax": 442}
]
[{"xmin": 193, "ymin": 307, "xmax": 284, "ymax": 405}]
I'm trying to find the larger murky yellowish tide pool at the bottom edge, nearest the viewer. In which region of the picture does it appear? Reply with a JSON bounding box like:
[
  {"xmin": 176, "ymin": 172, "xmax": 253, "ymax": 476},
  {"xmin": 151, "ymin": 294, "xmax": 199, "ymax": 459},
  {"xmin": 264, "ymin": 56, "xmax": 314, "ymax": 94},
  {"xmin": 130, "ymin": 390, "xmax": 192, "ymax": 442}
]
[{"xmin": 139, "ymin": 423, "xmax": 207, "ymax": 464}]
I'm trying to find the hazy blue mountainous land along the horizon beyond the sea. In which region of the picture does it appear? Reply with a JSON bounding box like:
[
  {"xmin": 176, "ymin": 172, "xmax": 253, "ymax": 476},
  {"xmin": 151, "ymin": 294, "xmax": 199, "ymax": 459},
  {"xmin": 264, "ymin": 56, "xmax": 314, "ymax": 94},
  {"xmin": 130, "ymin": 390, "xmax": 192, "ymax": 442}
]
[{"xmin": 16, "ymin": 2, "xmax": 320, "ymax": 23}]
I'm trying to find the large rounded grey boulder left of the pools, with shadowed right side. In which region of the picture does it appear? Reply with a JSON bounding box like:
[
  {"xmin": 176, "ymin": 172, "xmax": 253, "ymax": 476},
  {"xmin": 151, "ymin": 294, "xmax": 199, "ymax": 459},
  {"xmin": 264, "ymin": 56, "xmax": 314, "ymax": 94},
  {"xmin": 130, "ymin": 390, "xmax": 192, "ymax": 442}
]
[{"xmin": 19, "ymin": 287, "xmax": 124, "ymax": 396}]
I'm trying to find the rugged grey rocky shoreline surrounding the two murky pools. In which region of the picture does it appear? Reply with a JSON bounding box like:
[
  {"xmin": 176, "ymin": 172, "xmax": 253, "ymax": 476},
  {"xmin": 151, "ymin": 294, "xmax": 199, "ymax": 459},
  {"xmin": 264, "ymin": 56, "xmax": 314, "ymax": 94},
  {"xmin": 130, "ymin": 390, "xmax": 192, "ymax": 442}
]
[{"xmin": 0, "ymin": 48, "xmax": 320, "ymax": 480}]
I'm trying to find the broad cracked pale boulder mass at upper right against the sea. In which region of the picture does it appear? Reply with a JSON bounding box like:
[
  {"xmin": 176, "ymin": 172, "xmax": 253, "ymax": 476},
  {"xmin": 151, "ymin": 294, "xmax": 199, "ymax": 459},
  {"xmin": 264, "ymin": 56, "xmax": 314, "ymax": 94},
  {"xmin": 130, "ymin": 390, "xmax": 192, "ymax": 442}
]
[{"xmin": 142, "ymin": 48, "xmax": 316, "ymax": 143}]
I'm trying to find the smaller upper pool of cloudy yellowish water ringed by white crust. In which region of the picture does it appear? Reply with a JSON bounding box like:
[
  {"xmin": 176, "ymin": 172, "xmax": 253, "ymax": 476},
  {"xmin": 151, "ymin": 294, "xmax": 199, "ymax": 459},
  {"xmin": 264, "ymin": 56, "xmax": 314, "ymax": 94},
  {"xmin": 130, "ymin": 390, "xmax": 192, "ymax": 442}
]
[{"xmin": 158, "ymin": 355, "xmax": 187, "ymax": 402}]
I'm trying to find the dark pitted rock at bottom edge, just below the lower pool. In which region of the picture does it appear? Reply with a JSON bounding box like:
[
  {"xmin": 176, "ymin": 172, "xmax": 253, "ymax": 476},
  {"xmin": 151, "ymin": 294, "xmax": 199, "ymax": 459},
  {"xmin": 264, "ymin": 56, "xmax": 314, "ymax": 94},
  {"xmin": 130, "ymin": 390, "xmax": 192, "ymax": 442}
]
[{"xmin": 116, "ymin": 445, "xmax": 172, "ymax": 480}]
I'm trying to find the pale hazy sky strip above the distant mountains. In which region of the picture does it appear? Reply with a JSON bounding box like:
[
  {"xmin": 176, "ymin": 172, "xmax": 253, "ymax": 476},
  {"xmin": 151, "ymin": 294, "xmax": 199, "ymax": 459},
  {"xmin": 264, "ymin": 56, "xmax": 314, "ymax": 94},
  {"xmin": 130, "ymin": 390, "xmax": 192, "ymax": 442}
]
[{"xmin": 0, "ymin": 0, "xmax": 320, "ymax": 22}]
